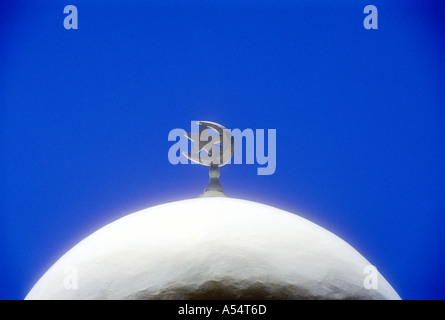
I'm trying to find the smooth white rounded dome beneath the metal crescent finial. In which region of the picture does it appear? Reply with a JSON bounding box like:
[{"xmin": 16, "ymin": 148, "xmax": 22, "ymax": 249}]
[{"xmin": 26, "ymin": 197, "xmax": 400, "ymax": 299}]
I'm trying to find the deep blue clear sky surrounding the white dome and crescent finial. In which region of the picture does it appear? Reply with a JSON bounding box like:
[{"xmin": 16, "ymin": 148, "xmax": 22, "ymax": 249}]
[{"xmin": 0, "ymin": 0, "xmax": 445, "ymax": 299}]
